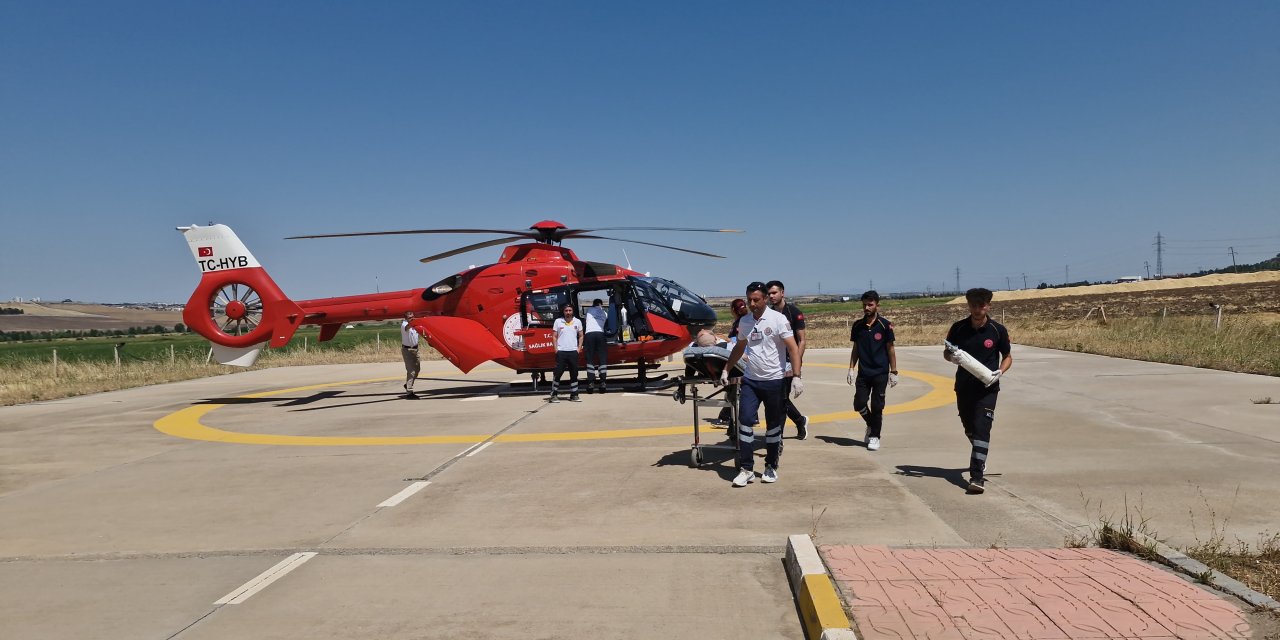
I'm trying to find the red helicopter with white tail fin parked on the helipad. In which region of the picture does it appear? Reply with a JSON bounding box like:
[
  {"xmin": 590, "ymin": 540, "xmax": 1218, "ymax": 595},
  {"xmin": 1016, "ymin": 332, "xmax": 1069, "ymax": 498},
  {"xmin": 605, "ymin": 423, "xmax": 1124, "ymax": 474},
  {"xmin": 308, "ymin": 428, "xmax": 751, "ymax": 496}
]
[{"xmin": 178, "ymin": 220, "xmax": 741, "ymax": 387}]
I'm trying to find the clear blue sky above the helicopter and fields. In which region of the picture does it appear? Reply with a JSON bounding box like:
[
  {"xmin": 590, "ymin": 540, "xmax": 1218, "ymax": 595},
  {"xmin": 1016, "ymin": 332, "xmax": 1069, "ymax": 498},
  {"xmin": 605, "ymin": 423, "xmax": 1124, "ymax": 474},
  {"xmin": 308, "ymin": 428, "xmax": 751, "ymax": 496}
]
[{"xmin": 0, "ymin": 0, "xmax": 1280, "ymax": 302}]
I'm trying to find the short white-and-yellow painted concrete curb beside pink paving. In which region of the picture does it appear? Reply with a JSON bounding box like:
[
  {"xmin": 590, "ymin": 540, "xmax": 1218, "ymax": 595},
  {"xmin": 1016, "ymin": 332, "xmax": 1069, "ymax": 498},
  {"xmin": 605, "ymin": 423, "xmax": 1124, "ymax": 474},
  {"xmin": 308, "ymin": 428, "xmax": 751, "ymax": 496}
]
[{"xmin": 786, "ymin": 534, "xmax": 858, "ymax": 640}]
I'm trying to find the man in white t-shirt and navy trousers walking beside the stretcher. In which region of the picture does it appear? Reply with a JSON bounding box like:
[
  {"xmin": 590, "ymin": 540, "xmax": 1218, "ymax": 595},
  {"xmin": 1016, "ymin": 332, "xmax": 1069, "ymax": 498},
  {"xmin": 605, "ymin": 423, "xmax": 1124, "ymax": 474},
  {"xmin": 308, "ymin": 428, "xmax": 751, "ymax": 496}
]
[{"xmin": 721, "ymin": 282, "xmax": 804, "ymax": 486}]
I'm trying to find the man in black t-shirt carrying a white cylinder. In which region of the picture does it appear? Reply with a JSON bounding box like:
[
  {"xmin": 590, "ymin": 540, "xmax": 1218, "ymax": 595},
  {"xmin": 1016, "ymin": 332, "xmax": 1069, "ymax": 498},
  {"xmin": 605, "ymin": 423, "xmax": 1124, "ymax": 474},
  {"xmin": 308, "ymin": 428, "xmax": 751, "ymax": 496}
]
[{"xmin": 942, "ymin": 288, "xmax": 1014, "ymax": 493}]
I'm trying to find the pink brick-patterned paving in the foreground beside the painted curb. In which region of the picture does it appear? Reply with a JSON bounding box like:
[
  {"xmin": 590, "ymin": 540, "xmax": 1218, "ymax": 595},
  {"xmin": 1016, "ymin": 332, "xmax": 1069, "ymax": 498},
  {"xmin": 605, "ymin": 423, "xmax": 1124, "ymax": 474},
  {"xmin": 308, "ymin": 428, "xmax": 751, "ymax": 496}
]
[{"xmin": 819, "ymin": 545, "xmax": 1252, "ymax": 640}]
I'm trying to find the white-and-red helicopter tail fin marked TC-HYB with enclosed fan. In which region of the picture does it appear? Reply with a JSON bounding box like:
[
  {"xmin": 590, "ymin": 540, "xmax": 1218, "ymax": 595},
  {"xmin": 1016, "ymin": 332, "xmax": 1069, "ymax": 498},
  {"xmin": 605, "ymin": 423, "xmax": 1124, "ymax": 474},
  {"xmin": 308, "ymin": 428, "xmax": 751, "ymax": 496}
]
[{"xmin": 178, "ymin": 224, "xmax": 305, "ymax": 364}]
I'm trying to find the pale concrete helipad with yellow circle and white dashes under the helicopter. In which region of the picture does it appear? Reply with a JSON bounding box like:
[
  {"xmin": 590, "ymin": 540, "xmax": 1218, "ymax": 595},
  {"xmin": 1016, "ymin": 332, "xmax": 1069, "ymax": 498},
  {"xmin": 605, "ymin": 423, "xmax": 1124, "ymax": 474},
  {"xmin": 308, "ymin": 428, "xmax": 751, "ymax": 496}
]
[{"xmin": 0, "ymin": 347, "xmax": 1280, "ymax": 639}]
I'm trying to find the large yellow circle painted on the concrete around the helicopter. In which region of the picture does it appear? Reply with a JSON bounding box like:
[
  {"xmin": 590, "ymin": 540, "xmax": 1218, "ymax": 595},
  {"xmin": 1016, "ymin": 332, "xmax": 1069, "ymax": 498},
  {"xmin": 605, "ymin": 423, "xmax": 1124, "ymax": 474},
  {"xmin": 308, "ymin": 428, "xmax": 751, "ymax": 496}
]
[{"xmin": 155, "ymin": 362, "xmax": 955, "ymax": 447}]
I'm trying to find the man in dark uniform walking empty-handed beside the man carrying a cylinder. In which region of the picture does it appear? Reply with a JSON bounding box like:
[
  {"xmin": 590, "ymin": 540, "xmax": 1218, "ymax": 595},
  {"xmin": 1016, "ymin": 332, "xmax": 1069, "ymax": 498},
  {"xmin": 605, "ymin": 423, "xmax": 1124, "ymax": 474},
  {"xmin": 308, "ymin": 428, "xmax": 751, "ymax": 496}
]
[{"xmin": 845, "ymin": 291, "xmax": 897, "ymax": 451}]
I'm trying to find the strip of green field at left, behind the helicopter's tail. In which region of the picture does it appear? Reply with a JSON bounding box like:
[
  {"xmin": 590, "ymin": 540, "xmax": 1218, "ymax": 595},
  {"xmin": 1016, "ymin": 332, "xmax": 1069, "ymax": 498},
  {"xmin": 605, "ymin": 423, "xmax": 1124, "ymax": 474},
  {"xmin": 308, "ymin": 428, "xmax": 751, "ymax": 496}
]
[{"xmin": 0, "ymin": 324, "xmax": 399, "ymax": 364}]
